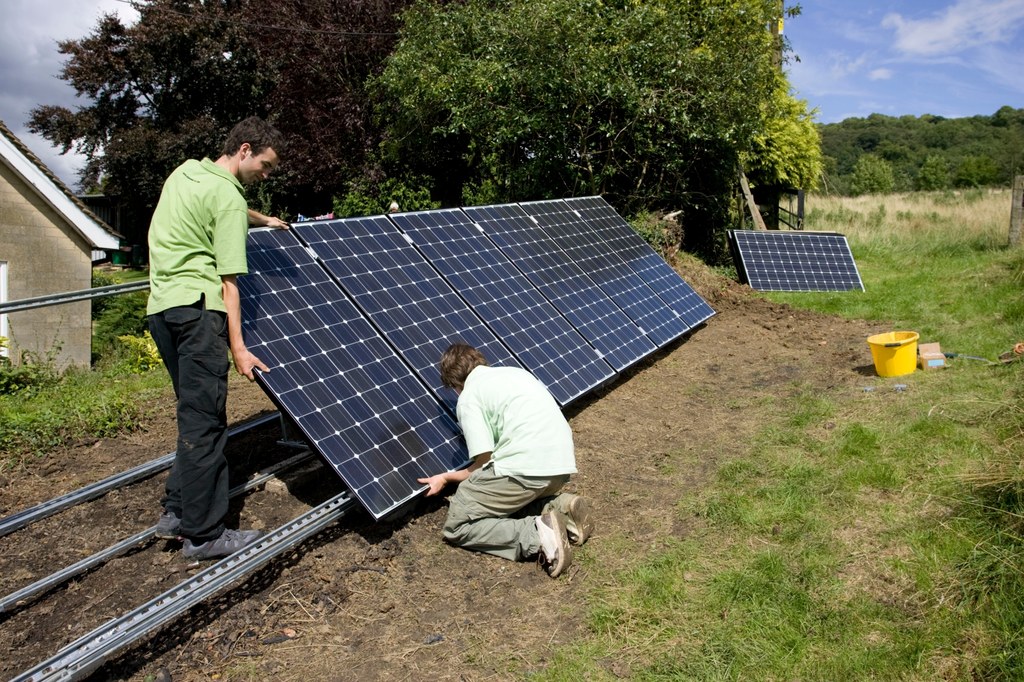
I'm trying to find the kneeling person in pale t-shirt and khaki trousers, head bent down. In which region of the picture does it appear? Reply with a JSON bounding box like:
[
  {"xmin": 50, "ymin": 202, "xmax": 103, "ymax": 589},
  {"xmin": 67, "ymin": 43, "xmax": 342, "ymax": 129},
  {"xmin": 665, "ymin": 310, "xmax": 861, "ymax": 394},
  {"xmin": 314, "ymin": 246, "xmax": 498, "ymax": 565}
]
[{"xmin": 418, "ymin": 343, "xmax": 594, "ymax": 578}]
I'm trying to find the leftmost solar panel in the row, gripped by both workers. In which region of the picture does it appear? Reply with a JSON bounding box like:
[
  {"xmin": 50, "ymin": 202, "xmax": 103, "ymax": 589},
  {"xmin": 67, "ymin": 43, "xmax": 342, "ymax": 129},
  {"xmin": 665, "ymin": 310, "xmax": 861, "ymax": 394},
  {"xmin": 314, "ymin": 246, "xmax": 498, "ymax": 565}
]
[{"xmin": 239, "ymin": 229, "xmax": 468, "ymax": 518}]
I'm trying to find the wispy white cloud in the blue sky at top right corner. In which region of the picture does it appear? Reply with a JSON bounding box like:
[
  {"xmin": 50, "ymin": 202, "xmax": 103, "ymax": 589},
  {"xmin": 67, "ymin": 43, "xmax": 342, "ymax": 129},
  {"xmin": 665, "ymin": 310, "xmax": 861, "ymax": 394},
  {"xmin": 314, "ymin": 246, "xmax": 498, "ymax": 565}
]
[{"xmin": 882, "ymin": 0, "xmax": 1024, "ymax": 56}]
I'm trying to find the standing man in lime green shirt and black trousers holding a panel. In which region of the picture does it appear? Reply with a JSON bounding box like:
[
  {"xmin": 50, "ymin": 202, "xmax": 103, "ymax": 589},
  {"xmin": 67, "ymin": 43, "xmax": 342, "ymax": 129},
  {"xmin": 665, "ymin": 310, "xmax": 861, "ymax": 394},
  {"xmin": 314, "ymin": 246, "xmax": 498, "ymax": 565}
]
[{"xmin": 146, "ymin": 117, "xmax": 288, "ymax": 559}]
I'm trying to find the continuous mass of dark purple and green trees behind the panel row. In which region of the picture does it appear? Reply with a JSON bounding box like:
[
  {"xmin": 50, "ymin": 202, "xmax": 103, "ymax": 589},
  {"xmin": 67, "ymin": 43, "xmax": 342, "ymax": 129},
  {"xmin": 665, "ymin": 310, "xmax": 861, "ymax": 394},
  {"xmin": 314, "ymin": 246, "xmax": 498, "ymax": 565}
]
[{"xmin": 30, "ymin": 0, "xmax": 817, "ymax": 260}]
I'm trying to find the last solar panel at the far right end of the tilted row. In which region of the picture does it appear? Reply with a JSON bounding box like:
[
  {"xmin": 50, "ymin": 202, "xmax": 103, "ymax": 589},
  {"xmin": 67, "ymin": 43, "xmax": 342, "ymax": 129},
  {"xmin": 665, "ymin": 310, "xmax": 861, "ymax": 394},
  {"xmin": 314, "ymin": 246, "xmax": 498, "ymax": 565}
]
[{"xmin": 563, "ymin": 197, "xmax": 715, "ymax": 331}]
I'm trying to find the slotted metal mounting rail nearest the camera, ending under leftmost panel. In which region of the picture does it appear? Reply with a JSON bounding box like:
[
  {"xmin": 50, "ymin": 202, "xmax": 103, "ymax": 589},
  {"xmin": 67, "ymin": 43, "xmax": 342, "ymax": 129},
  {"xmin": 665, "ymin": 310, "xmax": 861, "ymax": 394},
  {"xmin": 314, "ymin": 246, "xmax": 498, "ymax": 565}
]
[{"xmin": 11, "ymin": 492, "xmax": 354, "ymax": 682}]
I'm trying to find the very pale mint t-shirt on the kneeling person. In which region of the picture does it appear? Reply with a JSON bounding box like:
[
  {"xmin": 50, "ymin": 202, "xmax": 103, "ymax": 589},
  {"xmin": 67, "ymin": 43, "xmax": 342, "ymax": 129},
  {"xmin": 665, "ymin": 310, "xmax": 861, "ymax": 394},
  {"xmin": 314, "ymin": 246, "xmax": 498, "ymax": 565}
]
[{"xmin": 456, "ymin": 366, "xmax": 577, "ymax": 476}]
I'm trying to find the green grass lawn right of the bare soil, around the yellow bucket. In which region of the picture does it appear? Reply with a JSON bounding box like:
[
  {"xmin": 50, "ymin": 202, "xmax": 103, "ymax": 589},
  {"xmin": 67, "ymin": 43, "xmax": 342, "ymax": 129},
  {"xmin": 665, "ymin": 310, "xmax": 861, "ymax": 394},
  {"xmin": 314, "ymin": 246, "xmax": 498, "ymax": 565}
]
[{"xmin": 540, "ymin": 190, "xmax": 1024, "ymax": 680}]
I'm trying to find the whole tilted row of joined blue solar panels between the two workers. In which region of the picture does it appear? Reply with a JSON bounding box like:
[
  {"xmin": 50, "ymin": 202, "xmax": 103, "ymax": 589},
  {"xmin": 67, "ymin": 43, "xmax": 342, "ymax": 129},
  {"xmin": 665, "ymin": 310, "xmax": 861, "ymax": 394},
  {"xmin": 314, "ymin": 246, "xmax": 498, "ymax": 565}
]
[{"xmin": 239, "ymin": 198, "xmax": 714, "ymax": 518}]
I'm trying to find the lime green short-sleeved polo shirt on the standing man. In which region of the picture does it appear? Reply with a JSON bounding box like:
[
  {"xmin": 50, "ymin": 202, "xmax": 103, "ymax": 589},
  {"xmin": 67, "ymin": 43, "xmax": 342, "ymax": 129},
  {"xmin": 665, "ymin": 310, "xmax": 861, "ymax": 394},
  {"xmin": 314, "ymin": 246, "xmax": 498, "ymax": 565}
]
[{"xmin": 146, "ymin": 159, "xmax": 249, "ymax": 314}]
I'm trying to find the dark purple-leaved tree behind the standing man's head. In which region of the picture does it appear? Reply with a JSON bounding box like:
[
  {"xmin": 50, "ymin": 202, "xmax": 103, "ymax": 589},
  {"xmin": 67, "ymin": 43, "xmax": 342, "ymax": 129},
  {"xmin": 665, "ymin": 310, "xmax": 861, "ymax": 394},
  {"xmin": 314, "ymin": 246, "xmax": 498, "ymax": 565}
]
[{"xmin": 30, "ymin": 0, "xmax": 410, "ymax": 231}]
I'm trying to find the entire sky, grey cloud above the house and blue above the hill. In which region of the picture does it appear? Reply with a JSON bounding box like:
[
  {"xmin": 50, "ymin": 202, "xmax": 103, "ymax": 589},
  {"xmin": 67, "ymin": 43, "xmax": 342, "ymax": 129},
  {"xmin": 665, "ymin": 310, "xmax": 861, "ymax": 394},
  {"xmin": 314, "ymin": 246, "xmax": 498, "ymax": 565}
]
[{"xmin": 0, "ymin": 0, "xmax": 1024, "ymax": 185}]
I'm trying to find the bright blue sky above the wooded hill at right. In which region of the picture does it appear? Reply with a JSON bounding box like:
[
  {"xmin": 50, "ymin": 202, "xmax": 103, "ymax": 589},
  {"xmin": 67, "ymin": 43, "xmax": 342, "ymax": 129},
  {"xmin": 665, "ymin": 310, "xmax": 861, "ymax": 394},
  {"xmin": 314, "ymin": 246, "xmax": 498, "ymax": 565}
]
[{"xmin": 783, "ymin": 0, "xmax": 1024, "ymax": 123}]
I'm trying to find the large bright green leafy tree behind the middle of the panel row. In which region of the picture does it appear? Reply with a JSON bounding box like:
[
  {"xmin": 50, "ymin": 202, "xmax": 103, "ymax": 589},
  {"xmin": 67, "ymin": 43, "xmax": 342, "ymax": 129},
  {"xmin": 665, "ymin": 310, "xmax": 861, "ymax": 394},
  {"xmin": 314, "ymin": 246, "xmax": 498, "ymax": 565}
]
[{"xmin": 377, "ymin": 0, "xmax": 781, "ymax": 258}]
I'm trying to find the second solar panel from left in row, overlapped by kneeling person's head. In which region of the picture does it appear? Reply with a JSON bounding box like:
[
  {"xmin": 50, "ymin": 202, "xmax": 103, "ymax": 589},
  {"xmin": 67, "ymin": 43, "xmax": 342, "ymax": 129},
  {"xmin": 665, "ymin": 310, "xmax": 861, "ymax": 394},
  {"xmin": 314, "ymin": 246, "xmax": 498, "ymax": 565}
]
[{"xmin": 293, "ymin": 216, "xmax": 519, "ymax": 414}]
